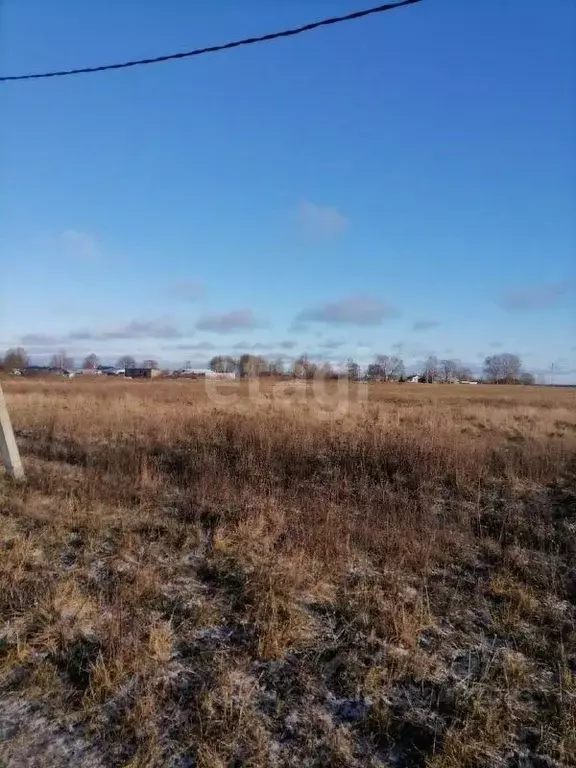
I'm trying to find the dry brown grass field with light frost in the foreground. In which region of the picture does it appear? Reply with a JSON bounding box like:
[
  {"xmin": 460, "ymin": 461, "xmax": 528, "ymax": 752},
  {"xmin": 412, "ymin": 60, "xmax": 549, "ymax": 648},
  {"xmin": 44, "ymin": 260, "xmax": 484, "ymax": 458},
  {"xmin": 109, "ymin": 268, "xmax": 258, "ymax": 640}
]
[{"xmin": 0, "ymin": 379, "xmax": 576, "ymax": 768}]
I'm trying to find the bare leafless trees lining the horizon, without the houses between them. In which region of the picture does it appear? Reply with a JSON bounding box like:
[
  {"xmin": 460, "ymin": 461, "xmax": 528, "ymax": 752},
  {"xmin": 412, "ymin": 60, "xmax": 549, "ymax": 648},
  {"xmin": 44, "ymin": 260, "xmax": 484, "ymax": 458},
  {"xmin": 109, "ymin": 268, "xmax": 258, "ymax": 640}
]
[{"xmin": 0, "ymin": 347, "xmax": 534, "ymax": 384}]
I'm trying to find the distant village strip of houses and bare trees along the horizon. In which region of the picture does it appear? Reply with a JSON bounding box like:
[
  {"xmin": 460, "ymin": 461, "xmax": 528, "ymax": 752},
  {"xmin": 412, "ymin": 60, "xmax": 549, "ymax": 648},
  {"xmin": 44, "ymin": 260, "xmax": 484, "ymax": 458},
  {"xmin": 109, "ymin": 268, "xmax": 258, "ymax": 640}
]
[{"xmin": 0, "ymin": 347, "xmax": 535, "ymax": 385}]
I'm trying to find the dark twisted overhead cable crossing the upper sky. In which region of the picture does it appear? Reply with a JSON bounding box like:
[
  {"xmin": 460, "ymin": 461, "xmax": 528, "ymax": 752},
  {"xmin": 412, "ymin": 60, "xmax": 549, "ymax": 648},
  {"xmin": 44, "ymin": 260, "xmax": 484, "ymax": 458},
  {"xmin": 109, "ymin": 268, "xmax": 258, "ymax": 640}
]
[{"xmin": 0, "ymin": 0, "xmax": 421, "ymax": 83}]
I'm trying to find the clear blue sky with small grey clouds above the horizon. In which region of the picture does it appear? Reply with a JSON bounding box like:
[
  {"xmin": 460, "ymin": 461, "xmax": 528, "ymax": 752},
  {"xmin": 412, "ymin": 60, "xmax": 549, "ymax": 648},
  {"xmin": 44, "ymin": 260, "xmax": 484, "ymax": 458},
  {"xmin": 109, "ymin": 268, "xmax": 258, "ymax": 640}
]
[{"xmin": 0, "ymin": 0, "xmax": 576, "ymax": 381}]
